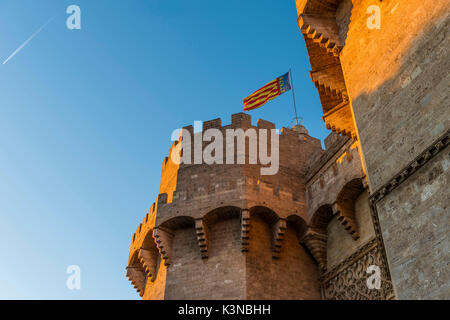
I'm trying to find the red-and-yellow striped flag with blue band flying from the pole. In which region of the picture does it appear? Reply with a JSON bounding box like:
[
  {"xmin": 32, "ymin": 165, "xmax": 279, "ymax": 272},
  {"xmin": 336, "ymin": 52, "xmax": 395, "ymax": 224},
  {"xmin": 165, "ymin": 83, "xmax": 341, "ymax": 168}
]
[{"xmin": 244, "ymin": 72, "xmax": 291, "ymax": 111}]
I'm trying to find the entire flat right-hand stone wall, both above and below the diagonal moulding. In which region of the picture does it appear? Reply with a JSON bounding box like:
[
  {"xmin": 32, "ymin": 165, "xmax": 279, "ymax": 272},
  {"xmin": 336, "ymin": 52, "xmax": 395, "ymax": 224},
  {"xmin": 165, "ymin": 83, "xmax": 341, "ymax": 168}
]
[{"xmin": 340, "ymin": 0, "xmax": 450, "ymax": 299}]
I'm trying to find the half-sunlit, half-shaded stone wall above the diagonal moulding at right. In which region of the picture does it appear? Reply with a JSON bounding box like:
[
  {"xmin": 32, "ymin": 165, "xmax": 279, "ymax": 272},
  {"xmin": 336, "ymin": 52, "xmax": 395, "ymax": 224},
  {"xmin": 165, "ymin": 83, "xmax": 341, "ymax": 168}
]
[{"xmin": 340, "ymin": 0, "xmax": 450, "ymax": 191}]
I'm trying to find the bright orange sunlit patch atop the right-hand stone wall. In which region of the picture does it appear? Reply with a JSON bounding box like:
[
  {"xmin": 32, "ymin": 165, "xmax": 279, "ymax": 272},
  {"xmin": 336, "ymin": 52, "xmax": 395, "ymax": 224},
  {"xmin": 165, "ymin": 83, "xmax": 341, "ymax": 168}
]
[{"xmin": 342, "ymin": 0, "xmax": 449, "ymax": 98}]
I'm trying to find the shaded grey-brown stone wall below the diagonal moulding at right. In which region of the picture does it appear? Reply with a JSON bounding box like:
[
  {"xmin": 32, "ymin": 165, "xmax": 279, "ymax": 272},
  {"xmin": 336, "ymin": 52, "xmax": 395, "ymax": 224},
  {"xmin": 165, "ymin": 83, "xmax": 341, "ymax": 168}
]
[{"xmin": 377, "ymin": 147, "xmax": 450, "ymax": 299}]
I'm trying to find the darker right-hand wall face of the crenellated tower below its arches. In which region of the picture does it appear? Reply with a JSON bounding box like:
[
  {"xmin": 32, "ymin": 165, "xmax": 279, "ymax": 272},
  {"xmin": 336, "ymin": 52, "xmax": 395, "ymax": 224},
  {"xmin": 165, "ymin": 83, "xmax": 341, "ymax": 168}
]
[{"xmin": 246, "ymin": 217, "xmax": 321, "ymax": 300}]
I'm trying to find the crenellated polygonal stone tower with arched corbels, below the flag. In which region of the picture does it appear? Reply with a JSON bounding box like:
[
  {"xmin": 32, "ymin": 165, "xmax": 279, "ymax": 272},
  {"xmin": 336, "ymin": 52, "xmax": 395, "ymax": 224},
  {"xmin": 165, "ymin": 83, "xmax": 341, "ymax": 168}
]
[{"xmin": 127, "ymin": 113, "xmax": 321, "ymax": 299}]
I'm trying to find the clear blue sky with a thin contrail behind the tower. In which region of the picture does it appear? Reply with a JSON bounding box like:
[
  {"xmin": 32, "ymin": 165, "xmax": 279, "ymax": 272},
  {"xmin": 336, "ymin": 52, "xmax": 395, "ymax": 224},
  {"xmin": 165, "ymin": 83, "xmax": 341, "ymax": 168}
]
[{"xmin": 0, "ymin": 0, "xmax": 328, "ymax": 299}]
